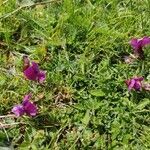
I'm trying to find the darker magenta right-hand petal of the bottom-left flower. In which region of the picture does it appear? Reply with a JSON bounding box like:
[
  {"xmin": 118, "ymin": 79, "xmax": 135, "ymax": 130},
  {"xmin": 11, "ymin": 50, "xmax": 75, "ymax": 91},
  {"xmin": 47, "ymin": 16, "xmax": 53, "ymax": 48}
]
[{"xmin": 22, "ymin": 100, "xmax": 37, "ymax": 116}]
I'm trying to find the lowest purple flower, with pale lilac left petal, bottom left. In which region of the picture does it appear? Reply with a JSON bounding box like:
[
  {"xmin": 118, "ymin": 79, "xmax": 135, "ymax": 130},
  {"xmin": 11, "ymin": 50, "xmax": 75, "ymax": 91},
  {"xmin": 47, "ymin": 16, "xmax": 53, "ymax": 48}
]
[{"xmin": 12, "ymin": 94, "xmax": 37, "ymax": 117}]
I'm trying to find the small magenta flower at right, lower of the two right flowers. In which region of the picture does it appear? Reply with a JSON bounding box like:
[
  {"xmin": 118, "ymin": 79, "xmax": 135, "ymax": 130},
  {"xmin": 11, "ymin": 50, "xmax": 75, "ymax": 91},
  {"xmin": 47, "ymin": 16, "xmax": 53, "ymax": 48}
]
[{"xmin": 125, "ymin": 77, "xmax": 143, "ymax": 91}]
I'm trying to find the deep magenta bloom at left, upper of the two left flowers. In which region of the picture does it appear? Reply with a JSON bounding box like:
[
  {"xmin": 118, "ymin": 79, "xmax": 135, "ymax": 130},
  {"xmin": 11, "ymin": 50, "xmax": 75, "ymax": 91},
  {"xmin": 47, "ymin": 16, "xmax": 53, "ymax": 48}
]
[{"xmin": 23, "ymin": 62, "xmax": 46, "ymax": 83}]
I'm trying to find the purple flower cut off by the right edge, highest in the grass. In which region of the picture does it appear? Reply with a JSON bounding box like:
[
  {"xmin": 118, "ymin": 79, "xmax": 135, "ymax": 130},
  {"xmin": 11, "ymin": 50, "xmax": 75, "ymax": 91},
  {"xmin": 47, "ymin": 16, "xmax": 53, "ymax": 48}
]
[{"xmin": 130, "ymin": 37, "xmax": 150, "ymax": 58}]
